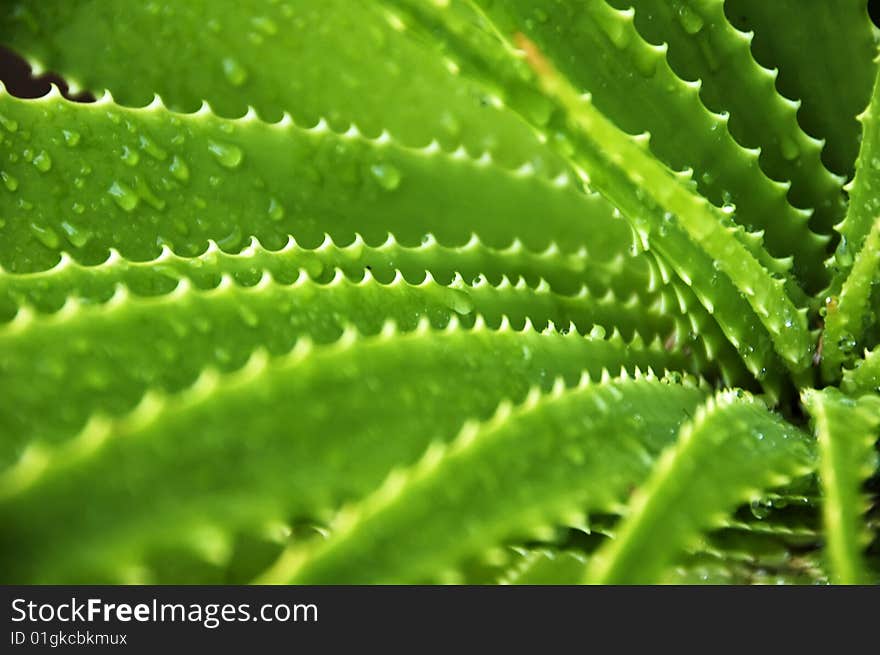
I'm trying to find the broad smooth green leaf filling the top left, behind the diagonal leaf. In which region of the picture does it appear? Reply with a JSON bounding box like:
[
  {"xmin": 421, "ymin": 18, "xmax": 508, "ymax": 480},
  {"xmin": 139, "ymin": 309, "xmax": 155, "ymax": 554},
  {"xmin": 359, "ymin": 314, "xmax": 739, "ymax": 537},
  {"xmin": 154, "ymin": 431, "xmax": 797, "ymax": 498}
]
[{"xmin": 0, "ymin": 0, "xmax": 564, "ymax": 176}]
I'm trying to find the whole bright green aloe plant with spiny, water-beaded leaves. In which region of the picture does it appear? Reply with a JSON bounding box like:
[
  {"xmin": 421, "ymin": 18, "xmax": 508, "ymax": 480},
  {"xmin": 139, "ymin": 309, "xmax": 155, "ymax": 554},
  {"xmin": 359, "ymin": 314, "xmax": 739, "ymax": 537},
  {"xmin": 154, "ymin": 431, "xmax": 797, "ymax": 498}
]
[{"xmin": 0, "ymin": 0, "xmax": 880, "ymax": 584}]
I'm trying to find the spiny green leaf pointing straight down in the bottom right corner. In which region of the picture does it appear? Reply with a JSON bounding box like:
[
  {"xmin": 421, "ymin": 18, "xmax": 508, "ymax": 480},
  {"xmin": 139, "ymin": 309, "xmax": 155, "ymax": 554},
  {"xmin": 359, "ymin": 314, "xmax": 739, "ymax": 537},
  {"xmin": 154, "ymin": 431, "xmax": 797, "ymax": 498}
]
[{"xmin": 804, "ymin": 388, "xmax": 880, "ymax": 584}]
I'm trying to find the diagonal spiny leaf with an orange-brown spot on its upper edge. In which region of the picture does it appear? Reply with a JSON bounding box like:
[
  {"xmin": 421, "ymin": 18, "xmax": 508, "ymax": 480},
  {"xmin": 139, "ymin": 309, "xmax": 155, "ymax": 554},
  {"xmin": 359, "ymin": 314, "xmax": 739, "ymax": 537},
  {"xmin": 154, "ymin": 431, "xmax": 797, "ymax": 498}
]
[{"xmin": 378, "ymin": 0, "xmax": 812, "ymax": 384}]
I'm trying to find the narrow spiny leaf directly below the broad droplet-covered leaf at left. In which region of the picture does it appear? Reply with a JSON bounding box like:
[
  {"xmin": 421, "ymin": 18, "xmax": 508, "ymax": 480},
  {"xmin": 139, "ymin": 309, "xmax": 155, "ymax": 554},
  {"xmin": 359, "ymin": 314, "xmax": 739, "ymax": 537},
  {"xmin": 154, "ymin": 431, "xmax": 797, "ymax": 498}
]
[{"xmin": 0, "ymin": 236, "xmax": 747, "ymax": 383}]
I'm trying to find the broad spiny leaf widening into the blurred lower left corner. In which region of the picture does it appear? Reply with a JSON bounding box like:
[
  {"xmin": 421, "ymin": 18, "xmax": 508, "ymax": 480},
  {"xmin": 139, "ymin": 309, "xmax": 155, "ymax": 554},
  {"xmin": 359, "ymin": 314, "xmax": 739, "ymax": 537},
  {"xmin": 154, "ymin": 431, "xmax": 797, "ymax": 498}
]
[{"xmin": 0, "ymin": 320, "xmax": 688, "ymax": 582}]
